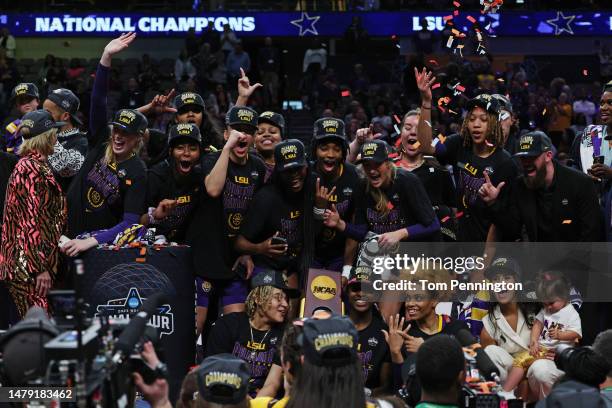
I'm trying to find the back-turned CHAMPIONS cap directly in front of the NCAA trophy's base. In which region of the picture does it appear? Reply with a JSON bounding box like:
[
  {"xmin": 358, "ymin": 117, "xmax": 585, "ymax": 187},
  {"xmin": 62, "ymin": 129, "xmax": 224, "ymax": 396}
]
[{"xmin": 302, "ymin": 316, "xmax": 358, "ymax": 366}]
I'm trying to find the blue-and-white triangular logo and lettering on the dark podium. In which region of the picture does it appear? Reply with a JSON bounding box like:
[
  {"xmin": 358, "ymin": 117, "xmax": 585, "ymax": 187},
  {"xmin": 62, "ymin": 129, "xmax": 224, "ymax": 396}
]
[{"xmin": 94, "ymin": 288, "xmax": 174, "ymax": 337}]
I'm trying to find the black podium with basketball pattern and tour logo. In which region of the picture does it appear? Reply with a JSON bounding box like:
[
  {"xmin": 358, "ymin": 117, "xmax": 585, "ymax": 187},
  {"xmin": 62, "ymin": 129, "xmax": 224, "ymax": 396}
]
[{"xmin": 81, "ymin": 247, "xmax": 195, "ymax": 401}]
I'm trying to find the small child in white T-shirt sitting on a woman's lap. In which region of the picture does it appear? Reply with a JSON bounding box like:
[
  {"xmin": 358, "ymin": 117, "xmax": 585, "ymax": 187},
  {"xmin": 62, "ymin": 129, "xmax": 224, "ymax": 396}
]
[{"xmin": 504, "ymin": 272, "xmax": 582, "ymax": 391}]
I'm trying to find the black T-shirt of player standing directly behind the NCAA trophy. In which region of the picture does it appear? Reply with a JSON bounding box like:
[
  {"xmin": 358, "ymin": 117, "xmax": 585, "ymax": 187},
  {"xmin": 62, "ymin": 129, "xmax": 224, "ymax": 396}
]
[{"xmin": 312, "ymin": 163, "xmax": 362, "ymax": 261}]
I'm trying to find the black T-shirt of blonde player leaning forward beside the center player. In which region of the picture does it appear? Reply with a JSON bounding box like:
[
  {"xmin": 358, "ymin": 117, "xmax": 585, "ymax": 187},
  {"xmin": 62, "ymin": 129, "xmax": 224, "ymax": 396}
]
[{"xmin": 355, "ymin": 168, "xmax": 439, "ymax": 241}]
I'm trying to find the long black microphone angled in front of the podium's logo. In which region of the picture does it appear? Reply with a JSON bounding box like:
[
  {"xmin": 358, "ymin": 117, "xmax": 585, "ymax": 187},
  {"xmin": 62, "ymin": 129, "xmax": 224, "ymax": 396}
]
[{"xmin": 113, "ymin": 292, "xmax": 168, "ymax": 363}]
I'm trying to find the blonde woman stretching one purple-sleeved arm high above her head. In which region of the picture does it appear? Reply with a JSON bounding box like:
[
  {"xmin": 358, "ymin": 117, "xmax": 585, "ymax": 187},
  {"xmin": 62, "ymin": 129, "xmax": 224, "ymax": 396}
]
[{"xmin": 62, "ymin": 33, "xmax": 148, "ymax": 256}]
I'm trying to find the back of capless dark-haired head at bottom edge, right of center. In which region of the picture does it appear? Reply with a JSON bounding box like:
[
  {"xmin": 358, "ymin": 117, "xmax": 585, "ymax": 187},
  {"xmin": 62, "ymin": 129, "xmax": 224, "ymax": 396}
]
[{"xmin": 416, "ymin": 335, "xmax": 465, "ymax": 408}]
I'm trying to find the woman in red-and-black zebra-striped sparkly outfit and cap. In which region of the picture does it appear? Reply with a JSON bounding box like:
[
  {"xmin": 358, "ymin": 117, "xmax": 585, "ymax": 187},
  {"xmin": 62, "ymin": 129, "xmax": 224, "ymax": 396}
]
[{"xmin": 0, "ymin": 110, "xmax": 66, "ymax": 318}]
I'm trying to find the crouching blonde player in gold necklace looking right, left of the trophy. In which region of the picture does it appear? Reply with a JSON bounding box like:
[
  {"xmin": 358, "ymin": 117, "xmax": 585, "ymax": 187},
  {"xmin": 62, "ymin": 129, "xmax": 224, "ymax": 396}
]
[{"xmin": 204, "ymin": 270, "xmax": 299, "ymax": 397}]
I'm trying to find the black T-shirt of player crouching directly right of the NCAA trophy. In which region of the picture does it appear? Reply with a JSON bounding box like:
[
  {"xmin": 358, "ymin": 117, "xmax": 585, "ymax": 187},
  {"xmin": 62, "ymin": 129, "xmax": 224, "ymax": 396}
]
[{"xmin": 357, "ymin": 317, "xmax": 391, "ymax": 389}]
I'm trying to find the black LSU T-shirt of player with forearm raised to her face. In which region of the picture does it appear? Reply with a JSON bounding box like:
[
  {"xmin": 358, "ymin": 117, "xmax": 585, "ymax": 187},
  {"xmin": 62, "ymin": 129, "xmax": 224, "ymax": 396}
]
[{"xmin": 187, "ymin": 152, "xmax": 270, "ymax": 279}]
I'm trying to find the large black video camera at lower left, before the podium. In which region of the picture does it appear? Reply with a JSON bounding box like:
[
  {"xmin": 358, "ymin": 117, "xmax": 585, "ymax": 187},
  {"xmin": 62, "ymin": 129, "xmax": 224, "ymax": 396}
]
[{"xmin": 0, "ymin": 264, "xmax": 167, "ymax": 408}]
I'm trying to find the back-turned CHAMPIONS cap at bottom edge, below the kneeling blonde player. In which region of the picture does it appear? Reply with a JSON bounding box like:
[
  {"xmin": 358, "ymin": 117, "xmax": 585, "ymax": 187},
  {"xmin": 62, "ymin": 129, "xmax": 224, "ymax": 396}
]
[{"xmin": 196, "ymin": 353, "xmax": 251, "ymax": 404}]
